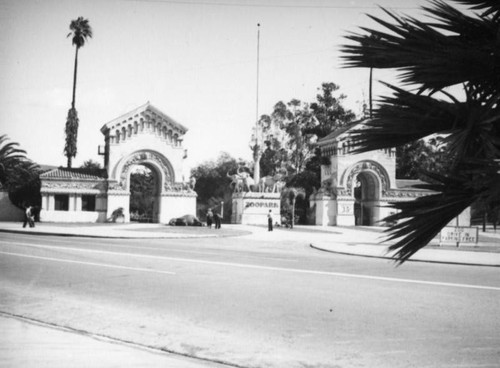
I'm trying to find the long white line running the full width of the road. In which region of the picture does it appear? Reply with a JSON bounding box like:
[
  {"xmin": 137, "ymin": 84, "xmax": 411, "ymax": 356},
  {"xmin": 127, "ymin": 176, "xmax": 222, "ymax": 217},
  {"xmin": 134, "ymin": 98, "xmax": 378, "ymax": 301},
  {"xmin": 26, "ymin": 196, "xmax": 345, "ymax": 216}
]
[{"xmin": 3, "ymin": 243, "xmax": 500, "ymax": 291}]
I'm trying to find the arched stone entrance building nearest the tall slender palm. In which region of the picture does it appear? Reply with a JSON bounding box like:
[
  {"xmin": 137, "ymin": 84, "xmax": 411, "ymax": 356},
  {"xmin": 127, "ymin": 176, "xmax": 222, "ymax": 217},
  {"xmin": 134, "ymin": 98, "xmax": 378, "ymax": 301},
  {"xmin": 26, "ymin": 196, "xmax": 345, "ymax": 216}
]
[{"xmin": 40, "ymin": 102, "xmax": 196, "ymax": 223}]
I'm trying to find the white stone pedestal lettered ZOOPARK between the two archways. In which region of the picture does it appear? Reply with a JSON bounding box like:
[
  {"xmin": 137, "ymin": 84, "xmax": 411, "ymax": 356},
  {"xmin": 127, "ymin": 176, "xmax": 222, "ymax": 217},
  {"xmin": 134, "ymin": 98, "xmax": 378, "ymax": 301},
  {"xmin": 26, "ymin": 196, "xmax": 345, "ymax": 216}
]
[{"xmin": 231, "ymin": 192, "xmax": 281, "ymax": 225}]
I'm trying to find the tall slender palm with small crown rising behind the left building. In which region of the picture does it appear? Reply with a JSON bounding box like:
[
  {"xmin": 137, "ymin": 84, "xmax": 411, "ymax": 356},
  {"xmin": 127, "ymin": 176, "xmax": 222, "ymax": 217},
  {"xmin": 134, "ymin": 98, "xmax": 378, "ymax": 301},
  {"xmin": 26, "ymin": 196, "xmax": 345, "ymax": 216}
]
[{"xmin": 64, "ymin": 17, "xmax": 92, "ymax": 168}]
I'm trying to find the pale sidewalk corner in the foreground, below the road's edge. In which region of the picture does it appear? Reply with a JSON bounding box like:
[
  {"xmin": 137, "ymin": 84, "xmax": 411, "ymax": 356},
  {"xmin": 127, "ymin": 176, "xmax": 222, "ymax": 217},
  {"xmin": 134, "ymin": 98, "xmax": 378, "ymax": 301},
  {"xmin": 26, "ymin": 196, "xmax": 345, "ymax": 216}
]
[{"xmin": 0, "ymin": 313, "xmax": 227, "ymax": 368}]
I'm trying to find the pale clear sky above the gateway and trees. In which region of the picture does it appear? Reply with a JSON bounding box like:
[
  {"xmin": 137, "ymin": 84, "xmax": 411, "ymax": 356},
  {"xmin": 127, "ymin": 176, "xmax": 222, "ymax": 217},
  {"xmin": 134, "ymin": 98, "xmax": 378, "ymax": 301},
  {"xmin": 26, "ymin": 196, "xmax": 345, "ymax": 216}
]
[{"xmin": 0, "ymin": 0, "xmax": 434, "ymax": 167}]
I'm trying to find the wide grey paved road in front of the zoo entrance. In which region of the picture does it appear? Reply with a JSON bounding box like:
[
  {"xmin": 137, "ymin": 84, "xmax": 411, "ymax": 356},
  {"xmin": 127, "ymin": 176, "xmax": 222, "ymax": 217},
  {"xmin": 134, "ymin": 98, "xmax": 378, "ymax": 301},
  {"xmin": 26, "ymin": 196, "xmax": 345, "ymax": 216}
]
[{"xmin": 0, "ymin": 234, "xmax": 500, "ymax": 368}]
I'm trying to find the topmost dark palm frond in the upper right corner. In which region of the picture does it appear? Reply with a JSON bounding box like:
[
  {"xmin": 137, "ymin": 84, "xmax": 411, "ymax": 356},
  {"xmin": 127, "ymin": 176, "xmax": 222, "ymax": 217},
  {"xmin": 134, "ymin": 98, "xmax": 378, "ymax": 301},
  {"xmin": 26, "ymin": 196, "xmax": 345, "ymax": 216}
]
[{"xmin": 341, "ymin": 1, "xmax": 500, "ymax": 90}]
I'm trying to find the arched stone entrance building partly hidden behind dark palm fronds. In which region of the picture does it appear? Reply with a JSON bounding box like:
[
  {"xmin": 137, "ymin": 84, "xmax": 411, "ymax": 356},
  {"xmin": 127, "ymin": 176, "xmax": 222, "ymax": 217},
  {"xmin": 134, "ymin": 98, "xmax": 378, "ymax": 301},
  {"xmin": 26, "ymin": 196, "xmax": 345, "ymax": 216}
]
[{"xmin": 310, "ymin": 121, "xmax": 428, "ymax": 226}]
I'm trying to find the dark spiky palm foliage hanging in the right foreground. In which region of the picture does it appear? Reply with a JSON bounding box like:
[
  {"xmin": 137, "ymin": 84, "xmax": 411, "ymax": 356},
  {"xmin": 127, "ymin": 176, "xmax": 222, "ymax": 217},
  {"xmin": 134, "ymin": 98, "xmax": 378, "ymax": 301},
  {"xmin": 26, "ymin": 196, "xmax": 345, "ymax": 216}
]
[{"xmin": 343, "ymin": 0, "xmax": 500, "ymax": 262}]
